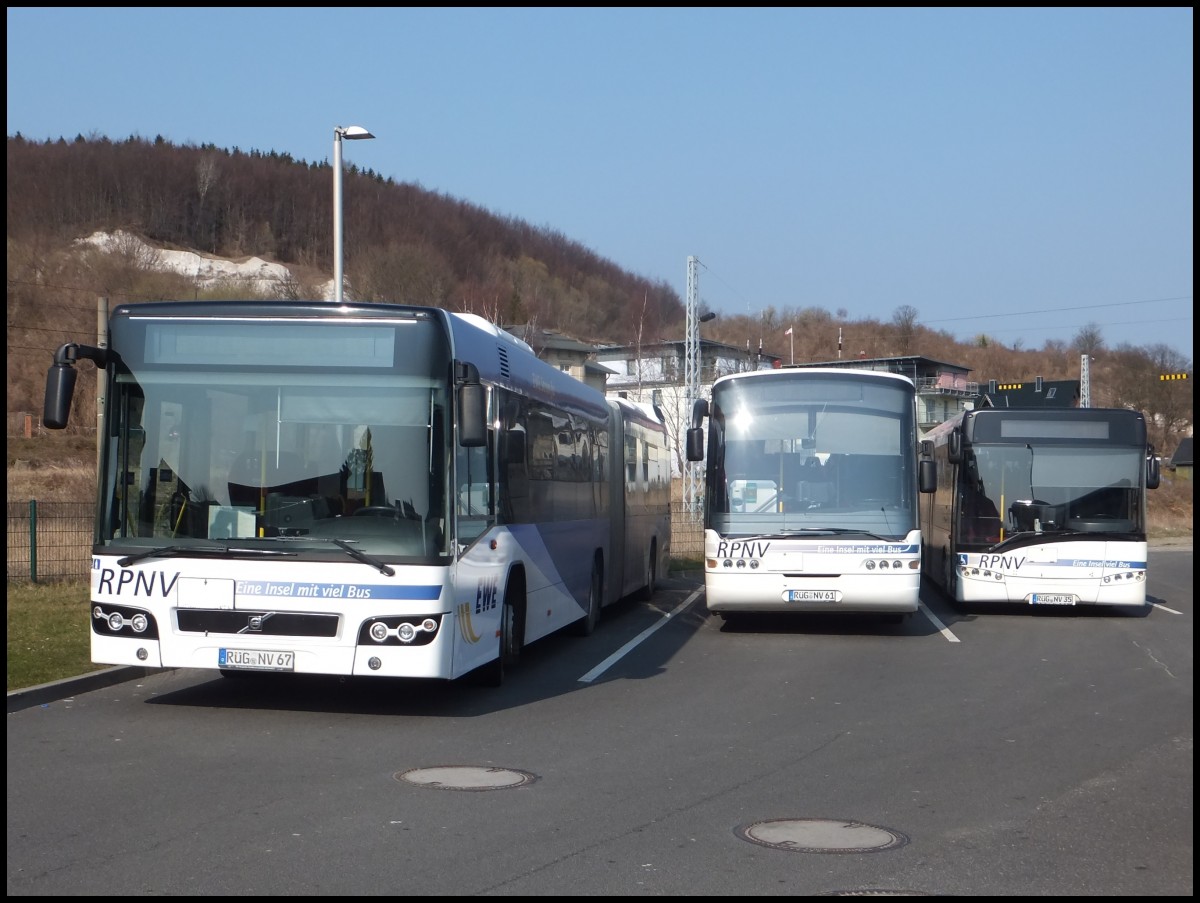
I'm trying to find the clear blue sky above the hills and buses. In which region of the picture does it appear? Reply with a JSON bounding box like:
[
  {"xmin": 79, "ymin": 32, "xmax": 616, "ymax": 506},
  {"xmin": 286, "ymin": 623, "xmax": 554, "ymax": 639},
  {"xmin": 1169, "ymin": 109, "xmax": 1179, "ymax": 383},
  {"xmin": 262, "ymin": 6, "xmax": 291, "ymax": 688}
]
[{"xmin": 7, "ymin": 7, "xmax": 1193, "ymax": 359}]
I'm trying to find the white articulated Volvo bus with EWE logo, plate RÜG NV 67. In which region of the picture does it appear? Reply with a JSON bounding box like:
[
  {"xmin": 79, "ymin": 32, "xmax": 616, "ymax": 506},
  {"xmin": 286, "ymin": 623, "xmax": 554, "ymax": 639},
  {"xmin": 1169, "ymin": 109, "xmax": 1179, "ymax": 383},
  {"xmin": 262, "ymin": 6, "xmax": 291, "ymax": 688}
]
[{"xmin": 44, "ymin": 301, "xmax": 671, "ymax": 684}]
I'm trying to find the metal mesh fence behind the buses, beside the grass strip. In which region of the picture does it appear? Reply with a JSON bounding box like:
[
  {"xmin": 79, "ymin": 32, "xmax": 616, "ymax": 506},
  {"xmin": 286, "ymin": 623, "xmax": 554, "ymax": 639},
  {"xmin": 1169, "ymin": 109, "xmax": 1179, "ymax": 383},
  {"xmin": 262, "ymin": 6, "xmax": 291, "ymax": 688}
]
[{"xmin": 8, "ymin": 501, "xmax": 704, "ymax": 582}]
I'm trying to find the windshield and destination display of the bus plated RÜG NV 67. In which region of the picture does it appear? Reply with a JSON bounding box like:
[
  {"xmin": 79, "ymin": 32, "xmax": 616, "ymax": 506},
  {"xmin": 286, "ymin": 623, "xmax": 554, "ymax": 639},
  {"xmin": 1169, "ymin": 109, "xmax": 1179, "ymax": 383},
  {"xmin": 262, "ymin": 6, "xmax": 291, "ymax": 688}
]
[{"xmin": 97, "ymin": 321, "xmax": 449, "ymax": 558}]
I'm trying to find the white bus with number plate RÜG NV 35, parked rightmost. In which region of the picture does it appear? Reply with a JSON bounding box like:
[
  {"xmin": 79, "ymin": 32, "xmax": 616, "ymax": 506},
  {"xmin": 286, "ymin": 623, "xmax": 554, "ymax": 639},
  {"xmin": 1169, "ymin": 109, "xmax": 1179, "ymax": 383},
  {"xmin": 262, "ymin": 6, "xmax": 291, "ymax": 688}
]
[{"xmin": 922, "ymin": 408, "xmax": 1159, "ymax": 609}]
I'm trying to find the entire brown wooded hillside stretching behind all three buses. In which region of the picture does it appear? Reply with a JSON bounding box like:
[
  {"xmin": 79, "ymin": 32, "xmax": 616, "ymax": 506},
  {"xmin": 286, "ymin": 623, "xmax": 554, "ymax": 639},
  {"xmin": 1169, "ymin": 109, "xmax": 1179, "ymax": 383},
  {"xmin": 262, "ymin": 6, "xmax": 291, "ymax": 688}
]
[{"xmin": 7, "ymin": 134, "xmax": 1192, "ymax": 447}]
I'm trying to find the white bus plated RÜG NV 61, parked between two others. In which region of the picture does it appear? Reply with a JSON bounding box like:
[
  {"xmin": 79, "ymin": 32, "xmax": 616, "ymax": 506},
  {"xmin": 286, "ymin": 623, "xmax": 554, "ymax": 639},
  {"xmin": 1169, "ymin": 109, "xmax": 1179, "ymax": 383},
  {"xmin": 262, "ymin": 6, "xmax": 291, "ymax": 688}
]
[{"xmin": 688, "ymin": 367, "xmax": 935, "ymax": 618}]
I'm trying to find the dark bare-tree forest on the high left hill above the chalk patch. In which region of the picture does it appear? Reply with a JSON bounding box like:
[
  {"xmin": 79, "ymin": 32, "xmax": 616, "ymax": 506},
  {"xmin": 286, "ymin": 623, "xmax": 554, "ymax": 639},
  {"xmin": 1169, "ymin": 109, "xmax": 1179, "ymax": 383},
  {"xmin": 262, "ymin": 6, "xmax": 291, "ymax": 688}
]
[{"xmin": 8, "ymin": 136, "xmax": 684, "ymax": 342}]
